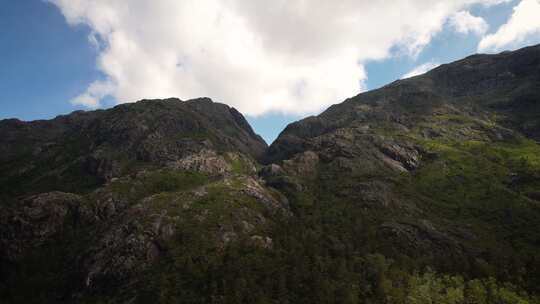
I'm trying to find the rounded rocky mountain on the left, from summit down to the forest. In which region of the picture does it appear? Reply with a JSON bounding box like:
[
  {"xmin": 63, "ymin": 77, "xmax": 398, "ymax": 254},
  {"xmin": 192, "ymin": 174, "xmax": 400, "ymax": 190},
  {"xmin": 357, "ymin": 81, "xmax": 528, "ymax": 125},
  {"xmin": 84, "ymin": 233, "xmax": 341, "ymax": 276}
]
[{"xmin": 0, "ymin": 99, "xmax": 288, "ymax": 303}]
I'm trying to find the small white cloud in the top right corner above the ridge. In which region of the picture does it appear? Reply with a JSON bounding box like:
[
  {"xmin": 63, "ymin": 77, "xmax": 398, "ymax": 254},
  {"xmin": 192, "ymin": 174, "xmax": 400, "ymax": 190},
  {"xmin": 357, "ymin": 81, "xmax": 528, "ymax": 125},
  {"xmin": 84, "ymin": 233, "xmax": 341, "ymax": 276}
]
[{"xmin": 478, "ymin": 0, "xmax": 540, "ymax": 52}]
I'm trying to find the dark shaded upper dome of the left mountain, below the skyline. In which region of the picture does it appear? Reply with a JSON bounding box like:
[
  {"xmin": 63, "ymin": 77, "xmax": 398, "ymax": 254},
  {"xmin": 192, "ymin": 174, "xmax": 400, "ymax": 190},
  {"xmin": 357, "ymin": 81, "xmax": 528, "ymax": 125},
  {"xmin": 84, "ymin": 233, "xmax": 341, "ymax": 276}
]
[{"xmin": 0, "ymin": 98, "xmax": 266, "ymax": 195}]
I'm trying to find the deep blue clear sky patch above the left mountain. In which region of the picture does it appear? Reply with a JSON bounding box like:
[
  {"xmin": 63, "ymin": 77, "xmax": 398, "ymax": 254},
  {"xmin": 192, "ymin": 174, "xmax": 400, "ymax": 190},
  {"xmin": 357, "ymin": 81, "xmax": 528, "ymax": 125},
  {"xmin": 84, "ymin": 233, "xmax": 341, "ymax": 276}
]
[{"xmin": 0, "ymin": 0, "xmax": 100, "ymax": 120}]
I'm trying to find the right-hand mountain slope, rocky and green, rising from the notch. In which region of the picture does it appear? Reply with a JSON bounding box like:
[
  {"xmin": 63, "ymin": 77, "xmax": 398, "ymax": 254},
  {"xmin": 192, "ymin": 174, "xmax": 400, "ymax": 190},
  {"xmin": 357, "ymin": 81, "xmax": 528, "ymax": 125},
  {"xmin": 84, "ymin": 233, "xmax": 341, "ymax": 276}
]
[{"xmin": 263, "ymin": 42, "xmax": 540, "ymax": 289}]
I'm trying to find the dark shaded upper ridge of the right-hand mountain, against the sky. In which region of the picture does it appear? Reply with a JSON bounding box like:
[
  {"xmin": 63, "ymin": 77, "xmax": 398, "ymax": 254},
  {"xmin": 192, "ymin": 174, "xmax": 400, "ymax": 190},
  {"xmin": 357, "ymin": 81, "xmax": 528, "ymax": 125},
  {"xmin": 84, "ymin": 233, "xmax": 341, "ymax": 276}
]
[{"xmin": 267, "ymin": 46, "xmax": 540, "ymax": 161}]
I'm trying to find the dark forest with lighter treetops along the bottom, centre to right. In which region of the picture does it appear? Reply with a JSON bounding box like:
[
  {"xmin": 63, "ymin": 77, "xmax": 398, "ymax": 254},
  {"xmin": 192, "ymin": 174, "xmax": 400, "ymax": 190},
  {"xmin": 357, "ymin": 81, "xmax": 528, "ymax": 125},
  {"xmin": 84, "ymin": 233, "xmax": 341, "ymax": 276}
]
[{"xmin": 139, "ymin": 225, "xmax": 540, "ymax": 304}]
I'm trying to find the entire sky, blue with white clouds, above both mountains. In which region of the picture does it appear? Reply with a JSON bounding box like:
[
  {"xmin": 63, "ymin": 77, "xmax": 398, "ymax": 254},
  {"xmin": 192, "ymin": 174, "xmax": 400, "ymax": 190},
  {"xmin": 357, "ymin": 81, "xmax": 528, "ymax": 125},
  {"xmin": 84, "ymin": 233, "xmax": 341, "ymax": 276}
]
[{"xmin": 0, "ymin": 0, "xmax": 540, "ymax": 143}]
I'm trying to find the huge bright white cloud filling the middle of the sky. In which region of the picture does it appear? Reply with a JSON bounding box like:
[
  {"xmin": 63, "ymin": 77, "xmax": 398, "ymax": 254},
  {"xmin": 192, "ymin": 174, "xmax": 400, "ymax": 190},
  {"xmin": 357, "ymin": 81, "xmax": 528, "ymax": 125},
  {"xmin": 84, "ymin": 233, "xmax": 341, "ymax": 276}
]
[{"xmin": 48, "ymin": 0, "xmax": 507, "ymax": 115}]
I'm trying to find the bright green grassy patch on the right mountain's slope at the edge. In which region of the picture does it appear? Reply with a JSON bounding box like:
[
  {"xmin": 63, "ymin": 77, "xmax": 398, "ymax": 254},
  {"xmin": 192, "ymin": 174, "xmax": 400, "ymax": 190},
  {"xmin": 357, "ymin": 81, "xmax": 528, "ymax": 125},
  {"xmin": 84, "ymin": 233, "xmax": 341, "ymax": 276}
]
[{"xmin": 408, "ymin": 140, "xmax": 540, "ymax": 254}]
